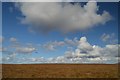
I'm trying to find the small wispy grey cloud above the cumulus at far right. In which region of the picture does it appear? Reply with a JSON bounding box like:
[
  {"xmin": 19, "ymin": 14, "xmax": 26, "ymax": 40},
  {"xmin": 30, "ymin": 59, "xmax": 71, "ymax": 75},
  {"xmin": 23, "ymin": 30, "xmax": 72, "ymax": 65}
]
[{"xmin": 101, "ymin": 33, "xmax": 118, "ymax": 44}]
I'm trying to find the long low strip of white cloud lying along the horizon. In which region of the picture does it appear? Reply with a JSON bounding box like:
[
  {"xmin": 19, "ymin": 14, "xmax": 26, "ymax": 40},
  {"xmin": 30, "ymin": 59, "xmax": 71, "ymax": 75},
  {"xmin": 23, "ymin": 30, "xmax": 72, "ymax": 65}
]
[{"xmin": 11, "ymin": 56, "xmax": 118, "ymax": 64}]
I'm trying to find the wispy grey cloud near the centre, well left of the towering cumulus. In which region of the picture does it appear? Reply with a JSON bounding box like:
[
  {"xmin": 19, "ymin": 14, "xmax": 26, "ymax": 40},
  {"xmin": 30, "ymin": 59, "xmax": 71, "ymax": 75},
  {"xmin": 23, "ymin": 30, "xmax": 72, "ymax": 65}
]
[{"xmin": 42, "ymin": 41, "xmax": 65, "ymax": 51}]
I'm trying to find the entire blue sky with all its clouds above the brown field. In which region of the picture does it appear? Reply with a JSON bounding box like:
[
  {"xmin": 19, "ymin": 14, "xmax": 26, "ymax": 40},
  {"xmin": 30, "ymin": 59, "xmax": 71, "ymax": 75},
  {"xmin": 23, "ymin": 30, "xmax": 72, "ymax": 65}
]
[{"xmin": 0, "ymin": 2, "xmax": 119, "ymax": 64}]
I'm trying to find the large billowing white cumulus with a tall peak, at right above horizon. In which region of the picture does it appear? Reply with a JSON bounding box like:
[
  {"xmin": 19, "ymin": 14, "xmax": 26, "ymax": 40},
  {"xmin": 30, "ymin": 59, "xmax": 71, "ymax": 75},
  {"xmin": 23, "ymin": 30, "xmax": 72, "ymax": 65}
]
[{"xmin": 64, "ymin": 37, "xmax": 119, "ymax": 63}]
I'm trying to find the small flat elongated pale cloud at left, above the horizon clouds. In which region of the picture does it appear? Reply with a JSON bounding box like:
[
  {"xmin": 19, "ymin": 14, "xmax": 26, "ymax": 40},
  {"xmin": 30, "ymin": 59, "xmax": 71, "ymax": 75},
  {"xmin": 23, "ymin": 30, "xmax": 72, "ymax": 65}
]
[{"xmin": 16, "ymin": 47, "xmax": 36, "ymax": 53}]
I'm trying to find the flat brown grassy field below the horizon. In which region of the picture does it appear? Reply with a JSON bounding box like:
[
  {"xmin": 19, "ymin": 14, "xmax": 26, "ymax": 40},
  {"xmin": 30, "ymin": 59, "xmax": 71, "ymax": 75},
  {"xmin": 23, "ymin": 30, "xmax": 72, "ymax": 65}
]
[{"xmin": 2, "ymin": 64, "xmax": 118, "ymax": 78}]
